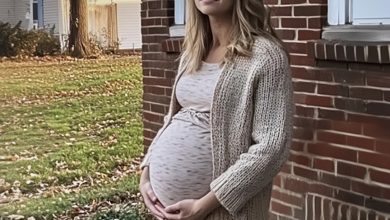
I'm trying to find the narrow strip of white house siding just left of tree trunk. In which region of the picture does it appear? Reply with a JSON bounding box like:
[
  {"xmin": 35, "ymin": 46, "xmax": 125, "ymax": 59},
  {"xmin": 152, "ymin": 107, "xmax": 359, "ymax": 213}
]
[{"xmin": 43, "ymin": 0, "xmax": 61, "ymax": 33}]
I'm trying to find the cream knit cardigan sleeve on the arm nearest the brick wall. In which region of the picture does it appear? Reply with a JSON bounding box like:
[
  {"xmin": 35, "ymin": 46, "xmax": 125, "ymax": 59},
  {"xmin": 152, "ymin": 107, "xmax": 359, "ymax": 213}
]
[{"xmin": 210, "ymin": 47, "xmax": 294, "ymax": 216}]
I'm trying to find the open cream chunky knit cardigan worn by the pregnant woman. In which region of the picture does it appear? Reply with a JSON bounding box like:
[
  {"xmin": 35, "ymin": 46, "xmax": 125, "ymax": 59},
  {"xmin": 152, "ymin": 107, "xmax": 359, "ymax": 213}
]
[{"xmin": 141, "ymin": 37, "xmax": 294, "ymax": 220}]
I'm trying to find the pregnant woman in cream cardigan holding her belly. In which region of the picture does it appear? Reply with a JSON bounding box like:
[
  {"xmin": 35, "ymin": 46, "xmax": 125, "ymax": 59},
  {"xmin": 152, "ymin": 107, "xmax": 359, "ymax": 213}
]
[{"xmin": 140, "ymin": 0, "xmax": 293, "ymax": 220}]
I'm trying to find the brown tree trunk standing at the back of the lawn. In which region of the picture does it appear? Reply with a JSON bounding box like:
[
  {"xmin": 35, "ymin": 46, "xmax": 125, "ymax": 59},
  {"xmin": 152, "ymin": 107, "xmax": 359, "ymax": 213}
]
[{"xmin": 69, "ymin": 0, "xmax": 91, "ymax": 58}]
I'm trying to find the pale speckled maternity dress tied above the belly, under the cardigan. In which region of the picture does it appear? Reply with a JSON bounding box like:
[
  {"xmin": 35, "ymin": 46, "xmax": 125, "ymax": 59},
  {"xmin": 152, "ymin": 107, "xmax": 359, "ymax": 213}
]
[{"xmin": 149, "ymin": 62, "xmax": 222, "ymax": 206}]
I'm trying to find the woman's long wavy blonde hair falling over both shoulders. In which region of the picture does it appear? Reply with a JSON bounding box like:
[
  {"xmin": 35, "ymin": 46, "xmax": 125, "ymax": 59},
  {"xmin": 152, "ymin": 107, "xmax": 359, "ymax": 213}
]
[{"xmin": 178, "ymin": 0, "xmax": 283, "ymax": 73}]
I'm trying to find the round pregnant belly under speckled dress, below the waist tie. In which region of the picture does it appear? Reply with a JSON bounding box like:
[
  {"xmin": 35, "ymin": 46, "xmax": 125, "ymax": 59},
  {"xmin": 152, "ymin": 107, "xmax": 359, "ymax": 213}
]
[{"xmin": 149, "ymin": 119, "xmax": 212, "ymax": 206}]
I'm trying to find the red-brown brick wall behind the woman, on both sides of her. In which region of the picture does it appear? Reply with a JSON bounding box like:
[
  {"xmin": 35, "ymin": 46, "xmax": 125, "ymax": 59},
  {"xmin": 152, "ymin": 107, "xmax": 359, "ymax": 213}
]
[{"xmin": 141, "ymin": 0, "xmax": 390, "ymax": 220}]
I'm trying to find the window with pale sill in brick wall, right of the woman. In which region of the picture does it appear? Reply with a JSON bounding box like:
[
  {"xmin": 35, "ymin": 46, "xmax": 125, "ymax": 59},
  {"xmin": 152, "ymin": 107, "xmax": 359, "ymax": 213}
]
[{"xmin": 322, "ymin": 0, "xmax": 390, "ymax": 41}]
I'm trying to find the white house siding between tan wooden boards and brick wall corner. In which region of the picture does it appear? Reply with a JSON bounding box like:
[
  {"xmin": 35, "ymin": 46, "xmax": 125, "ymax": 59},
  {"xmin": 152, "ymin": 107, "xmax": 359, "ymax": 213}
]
[{"xmin": 115, "ymin": 0, "xmax": 142, "ymax": 49}]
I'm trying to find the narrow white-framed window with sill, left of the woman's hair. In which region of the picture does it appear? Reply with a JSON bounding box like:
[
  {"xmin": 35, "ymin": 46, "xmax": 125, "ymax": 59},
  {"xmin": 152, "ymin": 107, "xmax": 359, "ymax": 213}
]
[{"xmin": 169, "ymin": 0, "xmax": 187, "ymax": 37}]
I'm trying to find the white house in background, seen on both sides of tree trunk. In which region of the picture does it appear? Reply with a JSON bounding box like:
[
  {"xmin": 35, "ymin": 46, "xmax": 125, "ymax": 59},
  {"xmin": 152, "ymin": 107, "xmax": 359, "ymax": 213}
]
[{"xmin": 0, "ymin": 0, "xmax": 142, "ymax": 50}]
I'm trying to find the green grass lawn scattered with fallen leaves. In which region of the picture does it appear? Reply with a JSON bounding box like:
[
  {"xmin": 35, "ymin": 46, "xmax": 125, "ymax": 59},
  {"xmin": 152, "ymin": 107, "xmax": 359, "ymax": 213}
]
[{"xmin": 0, "ymin": 57, "xmax": 149, "ymax": 219}]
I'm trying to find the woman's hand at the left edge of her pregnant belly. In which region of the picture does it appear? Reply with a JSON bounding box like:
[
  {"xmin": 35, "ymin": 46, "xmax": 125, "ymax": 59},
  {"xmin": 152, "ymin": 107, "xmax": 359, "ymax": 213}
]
[{"xmin": 139, "ymin": 167, "xmax": 165, "ymax": 219}]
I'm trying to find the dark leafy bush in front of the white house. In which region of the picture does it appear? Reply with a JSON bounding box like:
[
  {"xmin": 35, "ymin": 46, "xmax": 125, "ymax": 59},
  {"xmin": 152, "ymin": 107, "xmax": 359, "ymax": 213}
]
[{"xmin": 0, "ymin": 21, "xmax": 61, "ymax": 57}]
